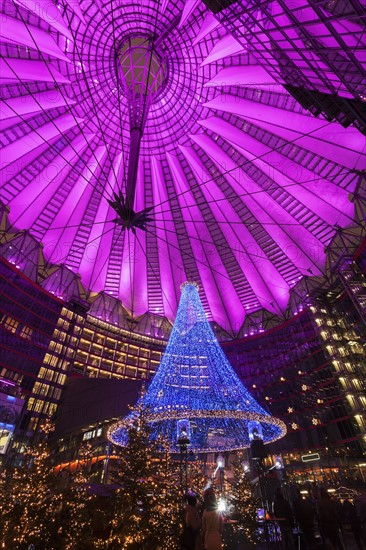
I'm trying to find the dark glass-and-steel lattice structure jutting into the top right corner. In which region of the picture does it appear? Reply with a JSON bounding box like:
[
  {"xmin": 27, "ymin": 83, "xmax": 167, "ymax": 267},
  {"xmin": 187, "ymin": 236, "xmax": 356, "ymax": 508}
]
[{"xmin": 204, "ymin": 0, "xmax": 366, "ymax": 133}]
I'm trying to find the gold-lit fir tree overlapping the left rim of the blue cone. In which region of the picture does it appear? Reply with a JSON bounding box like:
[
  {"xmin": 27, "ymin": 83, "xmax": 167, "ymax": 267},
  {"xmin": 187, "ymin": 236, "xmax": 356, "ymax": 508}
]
[{"xmin": 107, "ymin": 406, "xmax": 182, "ymax": 550}]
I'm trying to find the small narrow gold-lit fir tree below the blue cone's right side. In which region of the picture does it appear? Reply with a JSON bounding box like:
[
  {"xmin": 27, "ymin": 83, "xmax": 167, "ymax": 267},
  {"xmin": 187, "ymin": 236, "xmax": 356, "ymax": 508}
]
[{"xmin": 229, "ymin": 452, "xmax": 259, "ymax": 542}]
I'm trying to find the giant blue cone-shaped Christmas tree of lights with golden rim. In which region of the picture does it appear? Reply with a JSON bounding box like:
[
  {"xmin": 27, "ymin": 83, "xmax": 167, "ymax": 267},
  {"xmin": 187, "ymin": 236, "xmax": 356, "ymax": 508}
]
[{"xmin": 109, "ymin": 282, "xmax": 286, "ymax": 452}]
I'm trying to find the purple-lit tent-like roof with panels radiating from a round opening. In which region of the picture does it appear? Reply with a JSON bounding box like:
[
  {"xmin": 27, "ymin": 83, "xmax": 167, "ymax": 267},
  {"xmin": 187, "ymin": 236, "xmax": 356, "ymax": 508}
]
[{"xmin": 0, "ymin": 0, "xmax": 366, "ymax": 334}]
